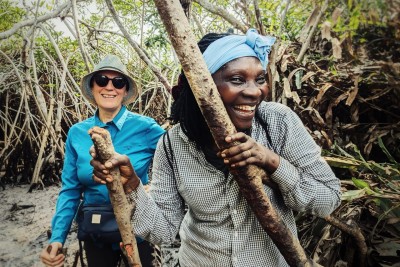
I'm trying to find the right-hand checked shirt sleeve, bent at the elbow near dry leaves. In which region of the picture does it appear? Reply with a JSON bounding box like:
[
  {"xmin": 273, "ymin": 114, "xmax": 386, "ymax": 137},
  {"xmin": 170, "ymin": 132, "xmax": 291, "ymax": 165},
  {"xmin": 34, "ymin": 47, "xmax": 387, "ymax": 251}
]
[{"xmin": 271, "ymin": 109, "xmax": 341, "ymax": 217}]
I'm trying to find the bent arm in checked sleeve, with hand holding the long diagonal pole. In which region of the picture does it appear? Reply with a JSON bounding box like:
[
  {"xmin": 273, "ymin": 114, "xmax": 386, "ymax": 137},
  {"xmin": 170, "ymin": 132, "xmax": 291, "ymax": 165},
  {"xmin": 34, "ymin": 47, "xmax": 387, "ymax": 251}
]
[{"xmin": 221, "ymin": 107, "xmax": 340, "ymax": 216}]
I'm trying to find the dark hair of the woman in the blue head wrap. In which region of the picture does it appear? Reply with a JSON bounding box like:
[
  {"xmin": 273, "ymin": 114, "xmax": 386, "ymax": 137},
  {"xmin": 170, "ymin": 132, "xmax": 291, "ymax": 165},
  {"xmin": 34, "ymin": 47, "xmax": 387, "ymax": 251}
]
[{"xmin": 170, "ymin": 33, "xmax": 229, "ymax": 148}]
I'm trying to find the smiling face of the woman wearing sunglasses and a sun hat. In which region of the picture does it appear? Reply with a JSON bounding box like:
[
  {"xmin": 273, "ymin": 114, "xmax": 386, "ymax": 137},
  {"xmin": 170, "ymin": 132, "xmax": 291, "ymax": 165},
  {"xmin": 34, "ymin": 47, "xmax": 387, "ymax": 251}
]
[{"xmin": 92, "ymin": 70, "xmax": 127, "ymax": 115}]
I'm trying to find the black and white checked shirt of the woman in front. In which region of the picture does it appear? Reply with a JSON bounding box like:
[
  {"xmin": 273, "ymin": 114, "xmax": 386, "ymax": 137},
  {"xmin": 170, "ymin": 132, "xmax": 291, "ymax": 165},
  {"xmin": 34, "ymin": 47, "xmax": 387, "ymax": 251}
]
[{"xmin": 131, "ymin": 102, "xmax": 340, "ymax": 267}]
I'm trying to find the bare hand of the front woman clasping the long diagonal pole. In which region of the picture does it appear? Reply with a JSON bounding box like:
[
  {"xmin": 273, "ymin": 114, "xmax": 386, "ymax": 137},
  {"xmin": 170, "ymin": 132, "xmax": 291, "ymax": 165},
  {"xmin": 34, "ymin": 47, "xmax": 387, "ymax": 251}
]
[{"xmin": 219, "ymin": 132, "xmax": 280, "ymax": 173}]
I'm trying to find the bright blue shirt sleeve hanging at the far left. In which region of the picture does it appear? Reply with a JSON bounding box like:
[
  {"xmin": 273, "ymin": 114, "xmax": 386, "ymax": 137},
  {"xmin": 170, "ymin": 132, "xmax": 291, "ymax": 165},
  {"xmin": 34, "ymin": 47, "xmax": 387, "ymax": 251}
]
[{"xmin": 50, "ymin": 128, "xmax": 82, "ymax": 244}]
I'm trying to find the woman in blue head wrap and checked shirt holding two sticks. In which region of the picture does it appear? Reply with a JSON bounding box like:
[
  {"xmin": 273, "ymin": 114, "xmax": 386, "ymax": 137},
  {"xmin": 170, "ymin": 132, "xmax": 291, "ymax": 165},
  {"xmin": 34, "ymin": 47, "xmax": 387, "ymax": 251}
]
[{"xmin": 92, "ymin": 30, "xmax": 340, "ymax": 267}]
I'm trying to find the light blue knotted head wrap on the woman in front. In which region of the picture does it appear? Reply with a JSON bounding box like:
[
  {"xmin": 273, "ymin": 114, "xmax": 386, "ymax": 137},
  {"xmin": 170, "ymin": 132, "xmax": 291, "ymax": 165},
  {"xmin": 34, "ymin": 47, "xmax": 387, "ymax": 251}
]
[{"xmin": 203, "ymin": 29, "xmax": 276, "ymax": 74}]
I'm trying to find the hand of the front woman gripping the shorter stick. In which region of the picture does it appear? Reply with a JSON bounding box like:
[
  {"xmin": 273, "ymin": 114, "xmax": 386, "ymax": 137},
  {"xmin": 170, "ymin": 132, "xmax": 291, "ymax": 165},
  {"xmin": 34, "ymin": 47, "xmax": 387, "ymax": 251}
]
[{"xmin": 90, "ymin": 146, "xmax": 140, "ymax": 194}]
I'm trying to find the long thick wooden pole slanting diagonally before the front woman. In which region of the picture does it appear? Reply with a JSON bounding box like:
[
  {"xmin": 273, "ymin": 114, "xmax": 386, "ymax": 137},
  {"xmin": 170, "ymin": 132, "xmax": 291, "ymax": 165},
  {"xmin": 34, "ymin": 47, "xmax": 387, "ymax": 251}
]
[{"xmin": 154, "ymin": 0, "xmax": 312, "ymax": 266}]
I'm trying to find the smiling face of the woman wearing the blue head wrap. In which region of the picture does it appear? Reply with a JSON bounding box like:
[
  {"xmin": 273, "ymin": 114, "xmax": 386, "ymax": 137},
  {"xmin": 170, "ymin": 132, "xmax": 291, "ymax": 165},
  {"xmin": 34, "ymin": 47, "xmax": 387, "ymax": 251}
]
[{"xmin": 212, "ymin": 57, "xmax": 268, "ymax": 131}]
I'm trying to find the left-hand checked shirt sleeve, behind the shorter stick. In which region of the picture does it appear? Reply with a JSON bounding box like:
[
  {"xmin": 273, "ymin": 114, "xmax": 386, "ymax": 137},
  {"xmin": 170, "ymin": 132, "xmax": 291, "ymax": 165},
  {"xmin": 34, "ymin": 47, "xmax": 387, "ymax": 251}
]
[{"xmin": 133, "ymin": 134, "xmax": 184, "ymax": 245}]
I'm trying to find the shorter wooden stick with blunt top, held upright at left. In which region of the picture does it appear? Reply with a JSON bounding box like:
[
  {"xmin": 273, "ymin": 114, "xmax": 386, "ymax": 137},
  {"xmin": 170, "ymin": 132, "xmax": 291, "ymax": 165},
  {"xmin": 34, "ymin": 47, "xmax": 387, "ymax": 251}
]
[{"xmin": 89, "ymin": 126, "xmax": 141, "ymax": 267}]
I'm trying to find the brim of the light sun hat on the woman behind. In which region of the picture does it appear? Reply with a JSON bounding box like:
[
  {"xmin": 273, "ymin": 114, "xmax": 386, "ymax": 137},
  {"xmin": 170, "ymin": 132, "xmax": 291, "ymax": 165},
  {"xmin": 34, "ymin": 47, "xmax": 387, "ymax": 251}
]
[{"xmin": 81, "ymin": 67, "xmax": 138, "ymax": 106}]
